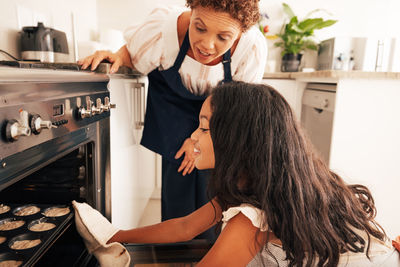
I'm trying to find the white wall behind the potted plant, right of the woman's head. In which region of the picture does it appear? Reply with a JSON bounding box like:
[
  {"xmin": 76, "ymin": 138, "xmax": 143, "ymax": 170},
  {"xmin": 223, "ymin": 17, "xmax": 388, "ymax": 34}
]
[{"xmin": 260, "ymin": 0, "xmax": 400, "ymax": 70}]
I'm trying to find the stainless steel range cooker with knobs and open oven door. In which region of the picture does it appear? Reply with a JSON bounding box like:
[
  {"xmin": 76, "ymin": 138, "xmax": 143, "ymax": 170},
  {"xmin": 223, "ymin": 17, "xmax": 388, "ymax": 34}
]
[{"xmin": 0, "ymin": 61, "xmax": 216, "ymax": 267}]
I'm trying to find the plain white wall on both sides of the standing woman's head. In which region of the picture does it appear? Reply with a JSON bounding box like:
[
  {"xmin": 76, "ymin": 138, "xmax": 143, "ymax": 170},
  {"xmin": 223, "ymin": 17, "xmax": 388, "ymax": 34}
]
[{"xmin": 97, "ymin": 0, "xmax": 400, "ymax": 67}]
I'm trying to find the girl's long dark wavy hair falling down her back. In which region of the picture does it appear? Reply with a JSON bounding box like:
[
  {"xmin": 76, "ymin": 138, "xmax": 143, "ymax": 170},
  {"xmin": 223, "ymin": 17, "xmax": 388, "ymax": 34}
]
[{"xmin": 209, "ymin": 82, "xmax": 387, "ymax": 266}]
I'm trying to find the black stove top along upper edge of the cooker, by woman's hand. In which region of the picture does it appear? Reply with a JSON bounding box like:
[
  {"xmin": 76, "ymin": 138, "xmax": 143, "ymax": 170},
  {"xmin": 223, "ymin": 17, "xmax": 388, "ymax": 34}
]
[{"xmin": 0, "ymin": 60, "xmax": 140, "ymax": 75}]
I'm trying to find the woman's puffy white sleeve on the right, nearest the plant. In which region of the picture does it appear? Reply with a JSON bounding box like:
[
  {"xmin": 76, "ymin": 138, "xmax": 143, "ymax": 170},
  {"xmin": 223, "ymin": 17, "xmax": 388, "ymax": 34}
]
[{"xmin": 232, "ymin": 27, "xmax": 268, "ymax": 83}]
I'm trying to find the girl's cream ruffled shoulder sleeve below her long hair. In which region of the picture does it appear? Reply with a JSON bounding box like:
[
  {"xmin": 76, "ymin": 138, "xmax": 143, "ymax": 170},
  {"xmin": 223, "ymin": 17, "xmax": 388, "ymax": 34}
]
[{"xmin": 222, "ymin": 204, "xmax": 268, "ymax": 232}]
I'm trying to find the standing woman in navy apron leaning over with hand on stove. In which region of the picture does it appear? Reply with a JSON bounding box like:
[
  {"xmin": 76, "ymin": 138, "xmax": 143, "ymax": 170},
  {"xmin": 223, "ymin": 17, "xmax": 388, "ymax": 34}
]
[{"xmin": 79, "ymin": 0, "xmax": 267, "ymax": 240}]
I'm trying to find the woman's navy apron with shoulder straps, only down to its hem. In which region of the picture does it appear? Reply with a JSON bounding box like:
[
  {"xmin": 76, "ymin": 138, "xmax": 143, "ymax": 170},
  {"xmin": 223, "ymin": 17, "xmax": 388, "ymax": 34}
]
[{"xmin": 141, "ymin": 33, "xmax": 232, "ymax": 163}]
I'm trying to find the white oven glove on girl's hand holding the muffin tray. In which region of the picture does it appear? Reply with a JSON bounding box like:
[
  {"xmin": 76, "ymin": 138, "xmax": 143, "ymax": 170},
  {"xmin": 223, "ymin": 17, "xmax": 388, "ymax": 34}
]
[{"xmin": 72, "ymin": 200, "xmax": 131, "ymax": 267}]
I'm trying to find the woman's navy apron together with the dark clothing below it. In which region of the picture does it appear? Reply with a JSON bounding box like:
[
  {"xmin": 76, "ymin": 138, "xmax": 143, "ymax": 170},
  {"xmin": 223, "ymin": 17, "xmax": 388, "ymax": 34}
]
[{"xmin": 140, "ymin": 32, "xmax": 232, "ymax": 239}]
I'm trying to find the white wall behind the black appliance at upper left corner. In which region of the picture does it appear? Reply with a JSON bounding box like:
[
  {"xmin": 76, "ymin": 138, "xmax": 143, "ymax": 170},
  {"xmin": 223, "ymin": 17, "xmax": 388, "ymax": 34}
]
[{"xmin": 0, "ymin": 0, "xmax": 97, "ymax": 61}]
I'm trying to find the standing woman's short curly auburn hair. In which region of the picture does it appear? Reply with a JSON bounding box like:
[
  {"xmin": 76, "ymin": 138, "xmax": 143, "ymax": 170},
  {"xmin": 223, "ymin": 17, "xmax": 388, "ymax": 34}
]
[{"xmin": 186, "ymin": 0, "xmax": 260, "ymax": 31}]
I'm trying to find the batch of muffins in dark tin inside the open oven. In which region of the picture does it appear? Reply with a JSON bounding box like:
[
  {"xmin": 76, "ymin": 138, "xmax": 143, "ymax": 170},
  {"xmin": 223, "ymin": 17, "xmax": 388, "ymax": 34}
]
[{"xmin": 0, "ymin": 203, "xmax": 72, "ymax": 267}]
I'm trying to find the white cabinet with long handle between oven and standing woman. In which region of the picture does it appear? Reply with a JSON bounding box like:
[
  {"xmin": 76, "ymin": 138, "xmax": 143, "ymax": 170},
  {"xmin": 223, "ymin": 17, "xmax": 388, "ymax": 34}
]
[{"xmin": 109, "ymin": 76, "xmax": 156, "ymax": 229}]
